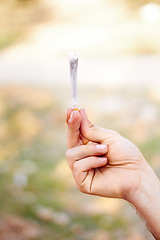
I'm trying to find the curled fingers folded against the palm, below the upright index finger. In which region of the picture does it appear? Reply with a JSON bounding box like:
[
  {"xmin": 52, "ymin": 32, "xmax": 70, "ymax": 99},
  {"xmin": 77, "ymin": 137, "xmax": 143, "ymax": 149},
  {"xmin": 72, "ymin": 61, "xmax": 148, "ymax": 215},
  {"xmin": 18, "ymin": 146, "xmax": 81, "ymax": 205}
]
[{"xmin": 66, "ymin": 143, "xmax": 108, "ymax": 191}]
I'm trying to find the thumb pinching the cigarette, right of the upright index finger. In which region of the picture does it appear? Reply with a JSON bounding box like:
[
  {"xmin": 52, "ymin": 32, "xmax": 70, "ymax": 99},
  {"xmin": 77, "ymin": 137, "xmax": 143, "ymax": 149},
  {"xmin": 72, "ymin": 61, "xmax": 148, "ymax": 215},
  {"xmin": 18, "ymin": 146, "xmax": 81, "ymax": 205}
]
[{"xmin": 80, "ymin": 109, "xmax": 116, "ymax": 143}]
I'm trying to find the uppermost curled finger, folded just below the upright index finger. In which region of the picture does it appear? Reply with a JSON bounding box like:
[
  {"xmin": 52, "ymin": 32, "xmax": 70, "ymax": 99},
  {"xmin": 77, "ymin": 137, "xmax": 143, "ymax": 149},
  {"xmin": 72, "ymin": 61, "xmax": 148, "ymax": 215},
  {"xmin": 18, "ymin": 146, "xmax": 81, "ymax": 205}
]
[{"xmin": 66, "ymin": 143, "xmax": 108, "ymax": 170}]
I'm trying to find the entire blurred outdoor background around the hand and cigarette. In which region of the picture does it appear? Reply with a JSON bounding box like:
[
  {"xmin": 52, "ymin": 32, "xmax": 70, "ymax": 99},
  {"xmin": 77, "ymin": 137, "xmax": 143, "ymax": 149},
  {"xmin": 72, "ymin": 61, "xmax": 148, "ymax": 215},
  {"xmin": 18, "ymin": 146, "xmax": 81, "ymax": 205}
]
[{"xmin": 0, "ymin": 0, "xmax": 160, "ymax": 240}]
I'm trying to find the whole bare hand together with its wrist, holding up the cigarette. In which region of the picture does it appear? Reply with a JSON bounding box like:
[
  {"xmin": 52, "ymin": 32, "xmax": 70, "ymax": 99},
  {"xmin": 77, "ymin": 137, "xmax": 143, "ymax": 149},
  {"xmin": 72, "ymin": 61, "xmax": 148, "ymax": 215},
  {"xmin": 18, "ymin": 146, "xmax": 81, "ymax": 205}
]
[{"xmin": 66, "ymin": 109, "xmax": 160, "ymax": 240}]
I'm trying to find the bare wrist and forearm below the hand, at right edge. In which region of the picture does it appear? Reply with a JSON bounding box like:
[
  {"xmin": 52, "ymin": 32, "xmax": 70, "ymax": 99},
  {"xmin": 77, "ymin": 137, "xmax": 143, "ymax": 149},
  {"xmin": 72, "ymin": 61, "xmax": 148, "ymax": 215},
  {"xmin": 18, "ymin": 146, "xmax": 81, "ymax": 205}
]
[{"xmin": 126, "ymin": 164, "xmax": 160, "ymax": 240}]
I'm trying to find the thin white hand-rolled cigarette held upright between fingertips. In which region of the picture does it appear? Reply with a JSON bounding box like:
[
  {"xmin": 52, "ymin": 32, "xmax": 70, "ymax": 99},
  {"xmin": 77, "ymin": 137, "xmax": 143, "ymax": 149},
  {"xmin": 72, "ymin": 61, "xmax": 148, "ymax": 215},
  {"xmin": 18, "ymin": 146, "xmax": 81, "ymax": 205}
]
[{"xmin": 68, "ymin": 52, "xmax": 78, "ymax": 110}]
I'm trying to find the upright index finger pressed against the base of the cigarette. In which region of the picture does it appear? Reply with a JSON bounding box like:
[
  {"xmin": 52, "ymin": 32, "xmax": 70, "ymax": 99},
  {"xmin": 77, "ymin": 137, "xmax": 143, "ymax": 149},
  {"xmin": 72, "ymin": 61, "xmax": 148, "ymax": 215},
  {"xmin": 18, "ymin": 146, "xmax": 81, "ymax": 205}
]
[{"xmin": 66, "ymin": 109, "xmax": 81, "ymax": 148}]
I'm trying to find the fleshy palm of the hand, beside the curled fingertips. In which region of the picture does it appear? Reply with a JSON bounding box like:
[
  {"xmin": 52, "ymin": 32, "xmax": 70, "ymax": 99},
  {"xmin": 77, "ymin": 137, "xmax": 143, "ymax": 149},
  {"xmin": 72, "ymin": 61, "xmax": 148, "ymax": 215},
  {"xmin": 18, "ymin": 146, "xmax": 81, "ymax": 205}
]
[{"xmin": 83, "ymin": 132, "xmax": 144, "ymax": 198}]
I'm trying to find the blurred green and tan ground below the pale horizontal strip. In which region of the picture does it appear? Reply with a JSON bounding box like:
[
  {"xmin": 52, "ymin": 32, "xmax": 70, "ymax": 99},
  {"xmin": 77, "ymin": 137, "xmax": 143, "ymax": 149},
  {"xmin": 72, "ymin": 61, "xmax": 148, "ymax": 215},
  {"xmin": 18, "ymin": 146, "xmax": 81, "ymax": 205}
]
[{"xmin": 0, "ymin": 85, "xmax": 160, "ymax": 240}]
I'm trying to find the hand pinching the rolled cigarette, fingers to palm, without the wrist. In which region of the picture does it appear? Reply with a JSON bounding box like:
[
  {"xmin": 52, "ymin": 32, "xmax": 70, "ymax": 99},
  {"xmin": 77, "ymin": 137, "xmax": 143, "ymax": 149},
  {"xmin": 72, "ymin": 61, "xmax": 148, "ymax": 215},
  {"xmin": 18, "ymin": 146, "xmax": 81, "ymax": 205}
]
[{"xmin": 66, "ymin": 109, "xmax": 147, "ymax": 199}]
